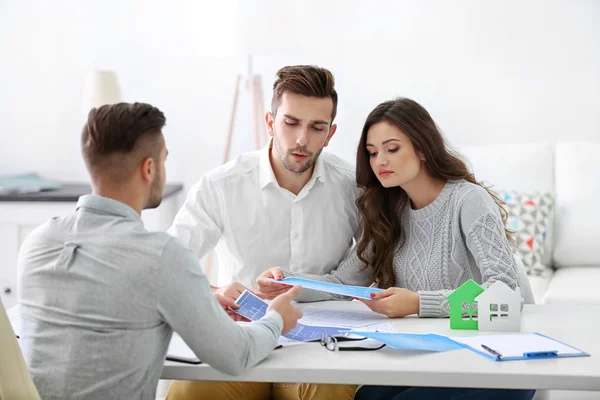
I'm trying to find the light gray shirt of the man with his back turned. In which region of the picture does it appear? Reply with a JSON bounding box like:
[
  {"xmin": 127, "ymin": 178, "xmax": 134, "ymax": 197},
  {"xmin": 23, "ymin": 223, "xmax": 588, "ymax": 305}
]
[{"xmin": 19, "ymin": 195, "xmax": 283, "ymax": 400}]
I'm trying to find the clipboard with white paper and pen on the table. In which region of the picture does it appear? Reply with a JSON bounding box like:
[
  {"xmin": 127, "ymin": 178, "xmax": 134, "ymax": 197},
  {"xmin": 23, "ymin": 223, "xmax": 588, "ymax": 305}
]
[{"xmin": 451, "ymin": 332, "xmax": 590, "ymax": 361}]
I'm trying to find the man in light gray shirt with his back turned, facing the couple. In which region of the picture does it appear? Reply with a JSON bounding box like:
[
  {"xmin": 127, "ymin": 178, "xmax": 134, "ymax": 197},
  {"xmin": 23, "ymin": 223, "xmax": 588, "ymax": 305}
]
[{"xmin": 19, "ymin": 103, "xmax": 302, "ymax": 400}]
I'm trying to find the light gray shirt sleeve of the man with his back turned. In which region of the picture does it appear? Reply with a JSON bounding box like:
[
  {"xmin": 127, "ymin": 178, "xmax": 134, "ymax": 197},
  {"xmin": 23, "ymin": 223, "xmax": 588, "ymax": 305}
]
[{"xmin": 156, "ymin": 238, "xmax": 283, "ymax": 375}]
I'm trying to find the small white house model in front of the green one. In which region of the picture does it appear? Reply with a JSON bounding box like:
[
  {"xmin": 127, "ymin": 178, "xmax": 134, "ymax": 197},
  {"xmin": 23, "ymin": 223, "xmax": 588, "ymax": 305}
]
[{"xmin": 475, "ymin": 281, "xmax": 521, "ymax": 332}]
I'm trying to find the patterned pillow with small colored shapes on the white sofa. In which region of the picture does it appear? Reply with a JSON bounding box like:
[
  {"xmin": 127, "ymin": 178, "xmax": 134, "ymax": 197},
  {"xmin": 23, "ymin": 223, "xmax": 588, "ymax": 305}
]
[{"xmin": 500, "ymin": 191, "xmax": 554, "ymax": 275}]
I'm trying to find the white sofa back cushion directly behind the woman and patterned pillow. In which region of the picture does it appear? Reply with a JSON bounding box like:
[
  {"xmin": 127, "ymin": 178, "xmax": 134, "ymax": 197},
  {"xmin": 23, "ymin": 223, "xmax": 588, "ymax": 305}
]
[{"xmin": 457, "ymin": 143, "xmax": 554, "ymax": 266}]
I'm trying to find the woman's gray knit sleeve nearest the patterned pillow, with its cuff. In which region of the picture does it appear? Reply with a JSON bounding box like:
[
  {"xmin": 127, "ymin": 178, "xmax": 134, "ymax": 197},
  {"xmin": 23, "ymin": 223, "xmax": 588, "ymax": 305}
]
[{"xmin": 418, "ymin": 188, "xmax": 517, "ymax": 317}]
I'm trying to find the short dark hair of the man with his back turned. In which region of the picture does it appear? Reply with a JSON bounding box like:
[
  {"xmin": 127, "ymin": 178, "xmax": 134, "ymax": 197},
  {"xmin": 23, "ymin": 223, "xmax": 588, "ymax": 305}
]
[{"xmin": 81, "ymin": 103, "xmax": 166, "ymax": 183}]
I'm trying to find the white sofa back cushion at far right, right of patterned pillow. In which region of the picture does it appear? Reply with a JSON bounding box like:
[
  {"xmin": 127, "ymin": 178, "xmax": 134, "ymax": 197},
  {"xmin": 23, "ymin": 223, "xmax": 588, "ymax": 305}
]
[{"xmin": 554, "ymin": 142, "xmax": 600, "ymax": 267}]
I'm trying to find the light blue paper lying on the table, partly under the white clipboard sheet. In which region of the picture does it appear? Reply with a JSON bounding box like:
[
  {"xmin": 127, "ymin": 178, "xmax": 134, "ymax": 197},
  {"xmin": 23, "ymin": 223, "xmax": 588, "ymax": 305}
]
[{"xmin": 352, "ymin": 331, "xmax": 463, "ymax": 351}]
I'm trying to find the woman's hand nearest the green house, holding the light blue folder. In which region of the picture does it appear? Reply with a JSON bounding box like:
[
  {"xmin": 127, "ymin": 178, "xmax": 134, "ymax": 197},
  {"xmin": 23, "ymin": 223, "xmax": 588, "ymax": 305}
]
[{"xmin": 357, "ymin": 288, "xmax": 419, "ymax": 318}]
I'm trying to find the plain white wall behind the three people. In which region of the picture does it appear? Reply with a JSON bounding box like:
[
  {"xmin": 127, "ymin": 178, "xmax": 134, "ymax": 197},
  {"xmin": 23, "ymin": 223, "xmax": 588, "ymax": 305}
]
[{"xmin": 0, "ymin": 0, "xmax": 600, "ymax": 195}]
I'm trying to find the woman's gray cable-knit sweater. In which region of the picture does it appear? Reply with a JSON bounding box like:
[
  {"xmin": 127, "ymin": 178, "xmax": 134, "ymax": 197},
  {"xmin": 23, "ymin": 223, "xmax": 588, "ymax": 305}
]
[{"xmin": 285, "ymin": 180, "xmax": 521, "ymax": 317}]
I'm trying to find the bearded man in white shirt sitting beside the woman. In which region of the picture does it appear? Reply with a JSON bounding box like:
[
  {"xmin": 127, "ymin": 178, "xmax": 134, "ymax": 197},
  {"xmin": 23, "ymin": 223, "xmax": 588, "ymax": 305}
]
[{"xmin": 168, "ymin": 66, "xmax": 359, "ymax": 400}]
